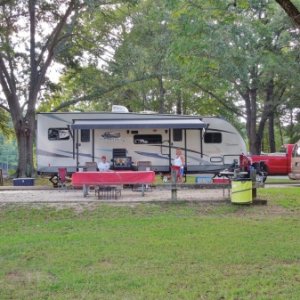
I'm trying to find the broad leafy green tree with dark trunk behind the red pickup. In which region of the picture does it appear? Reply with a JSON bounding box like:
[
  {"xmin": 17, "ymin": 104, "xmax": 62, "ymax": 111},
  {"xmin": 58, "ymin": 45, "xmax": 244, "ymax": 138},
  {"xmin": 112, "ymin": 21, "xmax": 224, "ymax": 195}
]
[{"xmin": 170, "ymin": 1, "xmax": 299, "ymax": 153}]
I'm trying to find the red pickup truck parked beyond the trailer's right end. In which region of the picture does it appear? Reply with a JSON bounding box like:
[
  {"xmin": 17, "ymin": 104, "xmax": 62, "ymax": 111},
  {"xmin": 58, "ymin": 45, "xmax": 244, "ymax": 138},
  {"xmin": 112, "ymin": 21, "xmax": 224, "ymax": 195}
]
[{"xmin": 247, "ymin": 144, "xmax": 295, "ymax": 175}]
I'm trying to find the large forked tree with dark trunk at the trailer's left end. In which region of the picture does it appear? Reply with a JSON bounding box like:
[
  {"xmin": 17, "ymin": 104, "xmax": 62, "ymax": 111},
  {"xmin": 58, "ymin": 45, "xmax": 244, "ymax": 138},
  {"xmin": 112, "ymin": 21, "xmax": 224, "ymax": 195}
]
[{"xmin": 0, "ymin": 0, "xmax": 77, "ymax": 177}]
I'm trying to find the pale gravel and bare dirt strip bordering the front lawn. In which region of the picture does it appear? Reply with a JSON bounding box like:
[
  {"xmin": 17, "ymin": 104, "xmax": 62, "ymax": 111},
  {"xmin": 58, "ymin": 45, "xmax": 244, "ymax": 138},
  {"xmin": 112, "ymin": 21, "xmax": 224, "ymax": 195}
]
[{"xmin": 0, "ymin": 187, "xmax": 298, "ymax": 218}]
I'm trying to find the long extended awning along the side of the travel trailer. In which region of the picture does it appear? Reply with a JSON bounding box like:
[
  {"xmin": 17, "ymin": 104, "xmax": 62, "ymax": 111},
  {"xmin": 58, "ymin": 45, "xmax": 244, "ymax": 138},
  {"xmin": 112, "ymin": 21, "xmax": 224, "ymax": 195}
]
[{"xmin": 71, "ymin": 118, "xmax": 208, "ymax": 129}]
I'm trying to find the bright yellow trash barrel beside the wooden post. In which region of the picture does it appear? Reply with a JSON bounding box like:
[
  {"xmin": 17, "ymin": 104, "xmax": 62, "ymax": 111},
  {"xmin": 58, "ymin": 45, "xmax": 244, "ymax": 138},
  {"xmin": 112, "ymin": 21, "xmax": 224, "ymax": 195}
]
[{"xmin": 231, "ymin": 179, "xmax": 252, "ymax": 204}]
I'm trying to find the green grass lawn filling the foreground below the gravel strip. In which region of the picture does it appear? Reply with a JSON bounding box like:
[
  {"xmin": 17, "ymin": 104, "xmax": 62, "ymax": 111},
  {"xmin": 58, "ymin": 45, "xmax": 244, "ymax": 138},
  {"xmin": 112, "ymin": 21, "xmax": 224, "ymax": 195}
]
[{"xmin": 0, "ymin": 187, "xmax": 300, "ymax": 299}]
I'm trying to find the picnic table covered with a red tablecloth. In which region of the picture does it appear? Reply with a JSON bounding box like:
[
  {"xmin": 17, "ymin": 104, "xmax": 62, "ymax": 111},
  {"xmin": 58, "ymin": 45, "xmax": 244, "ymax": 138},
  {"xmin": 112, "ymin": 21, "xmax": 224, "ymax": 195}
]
[{"xmin": 72, "ymin": 171, "xmax": 155, "ymax": 197}]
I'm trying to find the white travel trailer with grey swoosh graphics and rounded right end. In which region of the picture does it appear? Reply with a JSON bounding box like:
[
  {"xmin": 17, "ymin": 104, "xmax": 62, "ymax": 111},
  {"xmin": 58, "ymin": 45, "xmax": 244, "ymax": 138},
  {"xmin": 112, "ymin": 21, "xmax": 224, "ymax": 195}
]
[{"xmin": 37, "ymin": 112, "xmax": 246, "ymax": 174}]
